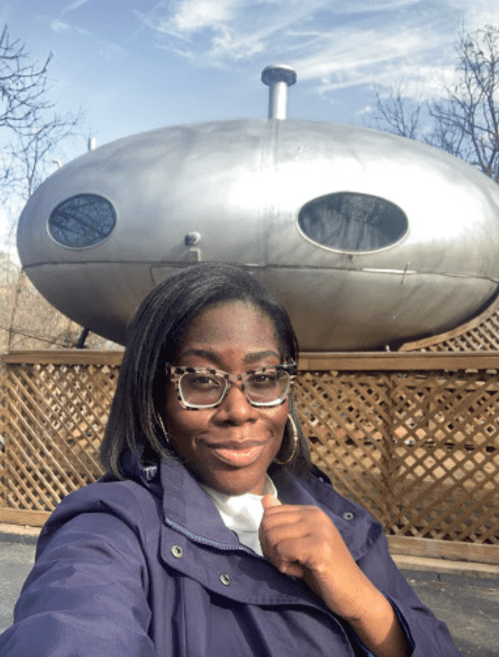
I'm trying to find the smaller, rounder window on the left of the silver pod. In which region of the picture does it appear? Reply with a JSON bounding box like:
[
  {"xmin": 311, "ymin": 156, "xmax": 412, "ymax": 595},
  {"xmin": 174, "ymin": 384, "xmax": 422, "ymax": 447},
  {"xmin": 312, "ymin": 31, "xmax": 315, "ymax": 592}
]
[{"xmin": 49, "ymin": 194, "xmax": 116, "ymax": 249}]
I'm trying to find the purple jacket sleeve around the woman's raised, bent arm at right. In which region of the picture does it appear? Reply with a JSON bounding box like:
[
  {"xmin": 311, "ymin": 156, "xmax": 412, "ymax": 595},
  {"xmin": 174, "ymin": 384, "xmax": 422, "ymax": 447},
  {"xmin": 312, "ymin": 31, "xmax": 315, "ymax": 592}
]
[{"xmin": 358, "ymin": 533, "xmax": 462, "ymax": 657}]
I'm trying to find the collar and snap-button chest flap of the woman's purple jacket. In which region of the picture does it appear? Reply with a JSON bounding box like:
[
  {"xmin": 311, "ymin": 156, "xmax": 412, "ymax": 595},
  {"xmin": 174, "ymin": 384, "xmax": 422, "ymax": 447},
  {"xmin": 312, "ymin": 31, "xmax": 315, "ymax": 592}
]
[{"xmin": 117, "ymin": 448, "xmax": 381, "ymax": 622}]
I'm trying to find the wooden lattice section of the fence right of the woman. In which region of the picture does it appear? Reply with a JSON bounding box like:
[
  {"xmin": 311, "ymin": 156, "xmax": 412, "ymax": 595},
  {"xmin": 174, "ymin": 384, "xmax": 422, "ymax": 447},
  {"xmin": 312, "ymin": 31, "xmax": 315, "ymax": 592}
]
[{"xmin": 295, "ymin": 371, "xmax": 499, "ymax": 543}]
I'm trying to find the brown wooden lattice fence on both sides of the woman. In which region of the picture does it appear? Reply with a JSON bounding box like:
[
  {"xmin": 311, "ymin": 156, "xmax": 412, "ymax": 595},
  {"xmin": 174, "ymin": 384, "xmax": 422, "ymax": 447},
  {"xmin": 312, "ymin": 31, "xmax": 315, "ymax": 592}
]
[{"xmin": 0, "ymin": 351, "xmax": 499, "ymax": 563}]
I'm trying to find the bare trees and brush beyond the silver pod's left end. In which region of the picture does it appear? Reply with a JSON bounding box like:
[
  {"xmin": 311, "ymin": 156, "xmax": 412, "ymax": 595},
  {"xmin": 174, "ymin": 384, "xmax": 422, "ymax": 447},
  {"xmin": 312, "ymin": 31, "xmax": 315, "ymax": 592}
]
[{"xmin": 0, "ymin": 27, "xmax": 112, "ymax": 351}]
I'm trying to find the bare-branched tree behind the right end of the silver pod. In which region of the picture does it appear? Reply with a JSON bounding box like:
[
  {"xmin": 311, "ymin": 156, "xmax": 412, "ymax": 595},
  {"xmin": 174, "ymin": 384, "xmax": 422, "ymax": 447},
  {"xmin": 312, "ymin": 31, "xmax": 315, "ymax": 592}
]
[{"xmin": 374, "ymin": 25, "xmax": 499, "ymax": 182}]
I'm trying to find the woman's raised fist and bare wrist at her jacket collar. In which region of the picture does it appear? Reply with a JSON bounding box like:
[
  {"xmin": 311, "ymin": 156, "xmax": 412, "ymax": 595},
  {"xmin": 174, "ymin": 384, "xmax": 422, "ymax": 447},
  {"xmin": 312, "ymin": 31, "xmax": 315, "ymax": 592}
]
[{"xmin": 260, "ymin": 495, "xmax": 407, "ymax": 657}]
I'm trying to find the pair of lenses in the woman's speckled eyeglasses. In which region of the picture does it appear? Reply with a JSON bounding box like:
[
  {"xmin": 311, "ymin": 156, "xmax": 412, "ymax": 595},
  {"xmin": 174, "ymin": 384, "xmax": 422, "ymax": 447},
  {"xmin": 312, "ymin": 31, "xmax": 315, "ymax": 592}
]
[{"xmin": 180, "ymin": 369, "xmax": 290, "ymax": 406}]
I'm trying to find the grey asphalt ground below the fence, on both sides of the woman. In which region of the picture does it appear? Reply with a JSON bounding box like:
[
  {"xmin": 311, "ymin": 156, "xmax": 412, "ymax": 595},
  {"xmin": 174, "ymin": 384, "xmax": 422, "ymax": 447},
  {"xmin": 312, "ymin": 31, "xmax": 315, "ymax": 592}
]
[{"xmin": 0, "ymin": 535, "xmax": 499, "ymax": 657}]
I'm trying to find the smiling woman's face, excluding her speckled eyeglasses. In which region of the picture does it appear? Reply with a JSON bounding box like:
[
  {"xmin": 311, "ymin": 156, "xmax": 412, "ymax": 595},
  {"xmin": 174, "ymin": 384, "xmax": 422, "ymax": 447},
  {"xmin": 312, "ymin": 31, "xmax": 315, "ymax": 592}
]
[{"xmin": 165, "ymin": 301, "xmax": 288, "ymax": 495}]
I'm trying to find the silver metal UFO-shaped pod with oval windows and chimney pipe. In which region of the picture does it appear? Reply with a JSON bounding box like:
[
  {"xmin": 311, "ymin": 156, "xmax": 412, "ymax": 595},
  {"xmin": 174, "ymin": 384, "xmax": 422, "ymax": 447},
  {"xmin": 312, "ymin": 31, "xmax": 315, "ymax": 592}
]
[{"xmin": 18, "ymin": 65, "xmax": 499, "ymax": 351}]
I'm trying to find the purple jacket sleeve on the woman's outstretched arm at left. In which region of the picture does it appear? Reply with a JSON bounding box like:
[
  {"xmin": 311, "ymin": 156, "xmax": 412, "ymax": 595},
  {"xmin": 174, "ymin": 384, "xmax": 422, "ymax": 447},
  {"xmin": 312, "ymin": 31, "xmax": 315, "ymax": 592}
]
[{"xmin": 0, "ymin": 484, "xmax": 155, "ymax": 657}]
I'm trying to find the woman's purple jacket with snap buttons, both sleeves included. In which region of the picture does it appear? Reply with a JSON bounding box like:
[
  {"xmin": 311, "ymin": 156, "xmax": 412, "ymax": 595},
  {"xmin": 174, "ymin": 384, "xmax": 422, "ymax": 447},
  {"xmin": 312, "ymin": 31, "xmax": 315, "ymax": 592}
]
[{"xmin": 0, "ymin": 459, "xmax": 460, "ymax": 657}]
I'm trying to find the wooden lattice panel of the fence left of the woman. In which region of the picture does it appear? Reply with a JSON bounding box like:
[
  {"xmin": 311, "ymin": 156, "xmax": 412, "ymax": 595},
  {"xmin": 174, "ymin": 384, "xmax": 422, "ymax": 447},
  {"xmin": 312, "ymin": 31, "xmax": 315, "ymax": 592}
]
[{"xmin": 0, "ymin": 364, "xmax": 117, "ymax": 511}]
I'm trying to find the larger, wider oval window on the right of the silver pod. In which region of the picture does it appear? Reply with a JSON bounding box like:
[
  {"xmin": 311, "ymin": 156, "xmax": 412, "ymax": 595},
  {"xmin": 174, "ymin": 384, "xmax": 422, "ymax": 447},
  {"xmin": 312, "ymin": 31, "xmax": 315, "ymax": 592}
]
[{"xmin": 298, "ymin": 192, "xmax": 408, "ymax": 251}]
